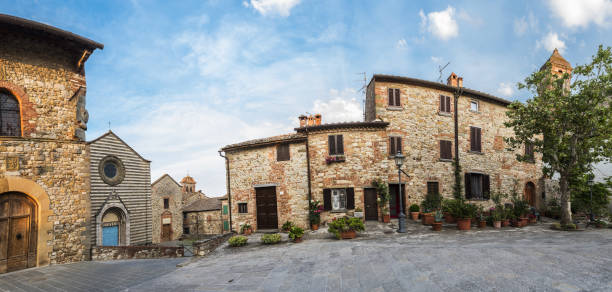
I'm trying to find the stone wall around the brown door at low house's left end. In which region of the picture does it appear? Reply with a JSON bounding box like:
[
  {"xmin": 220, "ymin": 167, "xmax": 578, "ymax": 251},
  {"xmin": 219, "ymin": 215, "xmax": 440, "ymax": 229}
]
[{"xmin": 226, "ymin": 143, "xmax": 309, "ymax": 231}]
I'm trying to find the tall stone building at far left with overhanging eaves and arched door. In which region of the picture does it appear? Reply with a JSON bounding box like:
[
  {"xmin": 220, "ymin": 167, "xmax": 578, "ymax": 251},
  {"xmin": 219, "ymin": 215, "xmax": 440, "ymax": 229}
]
[{"xmin": 0, "ymin": 14, "xmax": 104, "ymax": 272}]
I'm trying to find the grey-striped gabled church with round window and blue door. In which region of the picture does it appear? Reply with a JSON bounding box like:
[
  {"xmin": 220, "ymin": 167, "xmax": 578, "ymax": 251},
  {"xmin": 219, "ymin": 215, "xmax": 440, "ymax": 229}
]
[{"xmin": 88, "ymin": 131, "xmax": 152, "ymax": 246}]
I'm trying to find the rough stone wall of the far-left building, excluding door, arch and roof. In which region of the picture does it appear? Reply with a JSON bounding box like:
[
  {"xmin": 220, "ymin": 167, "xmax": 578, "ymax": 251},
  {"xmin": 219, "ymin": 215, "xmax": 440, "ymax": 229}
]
[{"xmin": 0, "ymin": 28, "xmax": 90, "ymax": 266}]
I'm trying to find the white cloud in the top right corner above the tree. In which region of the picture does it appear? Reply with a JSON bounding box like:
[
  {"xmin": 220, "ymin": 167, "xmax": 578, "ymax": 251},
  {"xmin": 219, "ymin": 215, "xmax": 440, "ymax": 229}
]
[{"xmin": 548, "ymin": 0, "xmax": 612, "ymax": 28}]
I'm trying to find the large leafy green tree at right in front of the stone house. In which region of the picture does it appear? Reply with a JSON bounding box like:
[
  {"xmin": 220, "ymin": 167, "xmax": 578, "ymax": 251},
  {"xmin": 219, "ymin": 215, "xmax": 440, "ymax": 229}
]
[{"xmin": 505, "ymin": 45, "xmax": 612, "ymax": 224}]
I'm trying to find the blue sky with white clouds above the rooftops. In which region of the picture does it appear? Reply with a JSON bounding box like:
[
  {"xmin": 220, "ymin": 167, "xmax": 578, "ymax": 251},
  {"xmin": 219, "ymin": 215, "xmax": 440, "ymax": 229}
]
[{"xmin": 0, "ymin": 0, "xmax": 612, "ymax": 196}]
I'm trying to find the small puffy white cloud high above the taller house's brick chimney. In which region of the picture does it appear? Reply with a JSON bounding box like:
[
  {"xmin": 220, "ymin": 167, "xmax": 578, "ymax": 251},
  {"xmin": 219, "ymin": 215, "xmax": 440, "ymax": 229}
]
[{"xmin": 419, "ymin": 6, "xmax": 459, "ymax": 40}]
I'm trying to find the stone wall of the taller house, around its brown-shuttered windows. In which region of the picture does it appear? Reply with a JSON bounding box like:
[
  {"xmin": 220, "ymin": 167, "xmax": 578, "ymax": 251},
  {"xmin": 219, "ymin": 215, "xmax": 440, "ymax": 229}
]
[{"xmin": 374, "ymin": 82, "xmax": 542, "ymax": 205}]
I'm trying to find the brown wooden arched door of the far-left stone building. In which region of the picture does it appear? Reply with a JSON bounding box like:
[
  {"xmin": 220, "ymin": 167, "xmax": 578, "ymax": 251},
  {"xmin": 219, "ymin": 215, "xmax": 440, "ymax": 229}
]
[{"xmin": 0, "ymin": 192, "xmax": 38, "ymax": 273}]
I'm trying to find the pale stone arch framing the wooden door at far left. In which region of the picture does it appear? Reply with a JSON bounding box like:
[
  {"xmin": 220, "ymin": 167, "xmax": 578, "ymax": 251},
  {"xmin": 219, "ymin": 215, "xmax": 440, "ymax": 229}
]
[{"xmin": 0, "ymin": 176, "xmax": 54, "ymax": 267}]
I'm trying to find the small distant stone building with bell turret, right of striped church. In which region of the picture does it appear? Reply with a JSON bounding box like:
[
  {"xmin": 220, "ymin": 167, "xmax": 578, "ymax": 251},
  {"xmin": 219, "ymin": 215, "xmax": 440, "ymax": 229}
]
[{"xmin": 151, "ymin": 174, "xmax": 206, "ymax": 243}]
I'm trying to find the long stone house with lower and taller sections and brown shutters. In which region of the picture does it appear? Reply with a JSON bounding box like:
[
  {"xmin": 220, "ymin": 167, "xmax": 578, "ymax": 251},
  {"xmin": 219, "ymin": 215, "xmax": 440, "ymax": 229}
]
[{"xmin": 221, "ymin": 51, "xmax": 571, "ymax": 230}]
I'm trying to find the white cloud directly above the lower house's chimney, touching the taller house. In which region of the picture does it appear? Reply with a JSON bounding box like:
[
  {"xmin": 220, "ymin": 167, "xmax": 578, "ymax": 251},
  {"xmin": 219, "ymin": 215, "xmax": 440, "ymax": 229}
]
[{"xmin": 312, "ymin": 88, "xmax": 363, "ymax": 123}]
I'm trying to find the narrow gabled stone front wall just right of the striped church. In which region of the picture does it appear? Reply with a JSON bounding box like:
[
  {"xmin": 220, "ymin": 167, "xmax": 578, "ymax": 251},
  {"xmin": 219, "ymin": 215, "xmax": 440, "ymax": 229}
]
[{"xmin": 151, "ymin": 174, "xmax": 183, "ymax": 243}]
